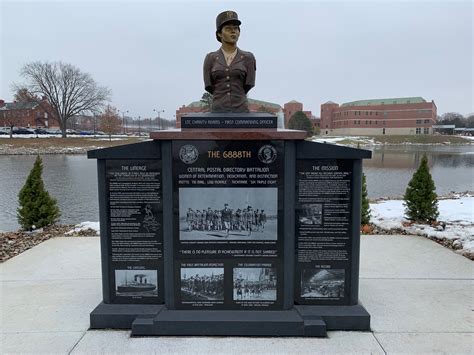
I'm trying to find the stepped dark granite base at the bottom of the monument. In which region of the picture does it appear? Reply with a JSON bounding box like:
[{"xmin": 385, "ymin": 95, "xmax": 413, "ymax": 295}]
[{"xmin": 90, "ymin": 303, "xmax": 370, "ymax": 337}]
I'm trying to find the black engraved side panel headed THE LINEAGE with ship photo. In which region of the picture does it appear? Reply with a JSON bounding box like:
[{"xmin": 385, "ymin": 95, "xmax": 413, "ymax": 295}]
[{"xmin": 105, "ymin": 159, "xmax": 164, "ymax": 304}]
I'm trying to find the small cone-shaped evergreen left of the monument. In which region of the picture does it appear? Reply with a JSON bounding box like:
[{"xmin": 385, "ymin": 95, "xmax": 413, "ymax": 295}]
[{"xmin": 17, "ymin": 155, "xmax": 61, "ymax": 230}]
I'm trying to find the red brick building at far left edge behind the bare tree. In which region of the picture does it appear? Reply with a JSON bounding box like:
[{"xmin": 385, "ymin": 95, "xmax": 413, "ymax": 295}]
[{"xmin": 0, "ymin": 100, "xmax": 57, "ymax": 127}]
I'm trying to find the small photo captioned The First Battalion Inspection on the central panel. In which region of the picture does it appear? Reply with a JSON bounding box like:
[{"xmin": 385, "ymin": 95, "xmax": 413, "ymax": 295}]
[{"xmin": 181, "ymin": 267, "xmax": 224, "ymax": 301}]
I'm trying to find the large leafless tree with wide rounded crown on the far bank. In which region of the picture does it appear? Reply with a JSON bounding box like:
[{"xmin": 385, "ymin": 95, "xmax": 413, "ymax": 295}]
[{"xmin": 16, "ymin": 62, "xmax": 111, "ymax": 137}]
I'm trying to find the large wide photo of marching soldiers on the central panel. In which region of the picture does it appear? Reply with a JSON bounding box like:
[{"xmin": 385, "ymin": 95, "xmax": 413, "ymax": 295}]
[{"xmin": 179, "ymin": 187, "xmax": 278, "ymax": 241}]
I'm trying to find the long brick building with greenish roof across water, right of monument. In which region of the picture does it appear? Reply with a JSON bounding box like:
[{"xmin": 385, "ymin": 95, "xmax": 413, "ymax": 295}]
[{"xmin": 320, "ymin": 97, "xmax": 437, "ymax": 135}]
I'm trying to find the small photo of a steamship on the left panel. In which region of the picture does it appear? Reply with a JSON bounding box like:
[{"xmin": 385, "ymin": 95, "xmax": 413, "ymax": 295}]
[{"xmin": 115, "ymin": 270, "xmax": 158, "ymax": 297}]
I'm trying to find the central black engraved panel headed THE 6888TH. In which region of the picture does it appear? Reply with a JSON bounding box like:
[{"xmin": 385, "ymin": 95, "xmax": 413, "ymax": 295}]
[{"xmin": 172, "ymin": 141, "xmax": 284, "ymax": 310}]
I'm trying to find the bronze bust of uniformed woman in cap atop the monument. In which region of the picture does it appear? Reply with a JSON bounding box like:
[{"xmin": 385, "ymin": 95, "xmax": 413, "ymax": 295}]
[{"xmin": 204, "ymin": 11, "xmax": 257, "ymax": 112}]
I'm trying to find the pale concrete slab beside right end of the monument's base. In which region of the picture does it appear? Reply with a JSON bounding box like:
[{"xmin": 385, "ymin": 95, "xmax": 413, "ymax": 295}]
[{"xmin": 359, "ymin": 279, "xmax": 474, "ymax": 333}]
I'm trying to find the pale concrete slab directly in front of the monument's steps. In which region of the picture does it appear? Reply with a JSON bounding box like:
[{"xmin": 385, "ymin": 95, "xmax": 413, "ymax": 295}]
[{"xmin": 72, "ymin": 331, "xmax": 383, "ymax": 355}]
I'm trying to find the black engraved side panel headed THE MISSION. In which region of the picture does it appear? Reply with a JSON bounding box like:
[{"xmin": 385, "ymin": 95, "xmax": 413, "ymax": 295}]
[{"xmin": 295, "ymin": 159, "xmax": 353, "ymax": 305}]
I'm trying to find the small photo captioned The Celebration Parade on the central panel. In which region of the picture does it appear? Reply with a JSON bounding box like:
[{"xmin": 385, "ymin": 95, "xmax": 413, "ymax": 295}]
[{"xmin": 233, "ymin": 267, "xmax": 277, "ymax": 301}]
